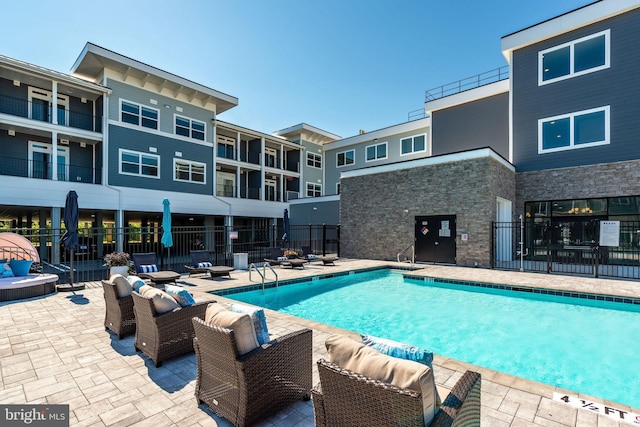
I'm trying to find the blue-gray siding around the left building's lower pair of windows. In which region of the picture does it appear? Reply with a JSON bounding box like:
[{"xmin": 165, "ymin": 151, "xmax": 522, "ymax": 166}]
[{"xmin": 108, "ymin": 125, "xmax": 214, "ymax": 194}]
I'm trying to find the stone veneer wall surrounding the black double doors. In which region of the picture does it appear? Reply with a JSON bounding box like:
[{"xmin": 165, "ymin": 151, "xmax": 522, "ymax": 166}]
[{"xmin": 340, "ymin": 156, "xmax": 515, "ymax": 267}]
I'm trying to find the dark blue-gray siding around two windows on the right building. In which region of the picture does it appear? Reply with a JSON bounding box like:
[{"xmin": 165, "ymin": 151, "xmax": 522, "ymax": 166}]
[{"xmin": 512, "ymin": 10, "xmax": 640, "ymax": 172}]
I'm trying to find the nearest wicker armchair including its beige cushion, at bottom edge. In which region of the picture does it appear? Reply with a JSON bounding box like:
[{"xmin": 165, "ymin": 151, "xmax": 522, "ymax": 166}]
[{"xmin": 311, "ymin": 336, "xmax": 481, "ymax": 427}]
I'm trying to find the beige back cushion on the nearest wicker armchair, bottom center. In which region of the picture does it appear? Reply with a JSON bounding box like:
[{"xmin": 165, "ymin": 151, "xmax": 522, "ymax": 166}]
[{"xmin": 325, "ymin": 335, "xmax": 436, "ymax": 425}]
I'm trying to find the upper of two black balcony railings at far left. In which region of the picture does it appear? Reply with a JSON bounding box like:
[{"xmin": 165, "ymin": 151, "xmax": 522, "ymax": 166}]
[{"xmin": 0, "ymin": 95, "xmax": 102, "ymax": 132}]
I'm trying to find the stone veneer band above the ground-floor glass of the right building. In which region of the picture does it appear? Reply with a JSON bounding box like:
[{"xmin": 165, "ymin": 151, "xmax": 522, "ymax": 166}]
[{"xmin": 514, "ymin": 160, "xmax": 640, "ymax": 215}]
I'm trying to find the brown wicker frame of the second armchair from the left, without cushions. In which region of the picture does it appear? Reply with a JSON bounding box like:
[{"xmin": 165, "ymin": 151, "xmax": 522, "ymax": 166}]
[{"xmin": 132, "ymin": 292, "xmax": 210, "ymax": 367}]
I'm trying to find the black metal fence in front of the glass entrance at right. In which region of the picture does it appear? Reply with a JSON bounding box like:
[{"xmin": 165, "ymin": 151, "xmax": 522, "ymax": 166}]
[{"xmin": 491, "ymin": 221, "xmax": 640, "ymax": 279}]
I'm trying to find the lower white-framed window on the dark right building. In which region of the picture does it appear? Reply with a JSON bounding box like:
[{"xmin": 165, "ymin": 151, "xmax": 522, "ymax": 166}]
[{"xmin": 538, "ymin": 105, "xmax": 609, "ymax": 153}]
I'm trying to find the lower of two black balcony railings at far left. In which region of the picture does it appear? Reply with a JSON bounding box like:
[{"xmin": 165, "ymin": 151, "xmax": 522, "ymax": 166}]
[{"xmin": 0, "ymin": 156, "xmax": 101, "ymax": 184}]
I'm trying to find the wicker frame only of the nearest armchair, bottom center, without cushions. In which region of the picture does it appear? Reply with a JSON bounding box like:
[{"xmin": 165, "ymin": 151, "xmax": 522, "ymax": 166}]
[{"xmin": 311, "ymin": 359, "xmax": 481, "ymax": 427}]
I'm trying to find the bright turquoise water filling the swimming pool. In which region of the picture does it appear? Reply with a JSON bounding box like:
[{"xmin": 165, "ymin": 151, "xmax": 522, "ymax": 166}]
[{"xmin": 221, "ymin": 270, "xmax": 640, "ymax": 408}]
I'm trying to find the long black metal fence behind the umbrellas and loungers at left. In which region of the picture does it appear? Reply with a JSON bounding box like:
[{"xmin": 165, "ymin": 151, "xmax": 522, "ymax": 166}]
[{"xmin": 0, "ymin": 224, "xmax": 340, "ymax": 284}]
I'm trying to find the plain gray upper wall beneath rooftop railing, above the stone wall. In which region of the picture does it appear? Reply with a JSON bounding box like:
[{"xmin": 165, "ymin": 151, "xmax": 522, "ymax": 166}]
[{"xmin": 431, "ymin": 93, "xmax": 509, "ymax": 159}]
